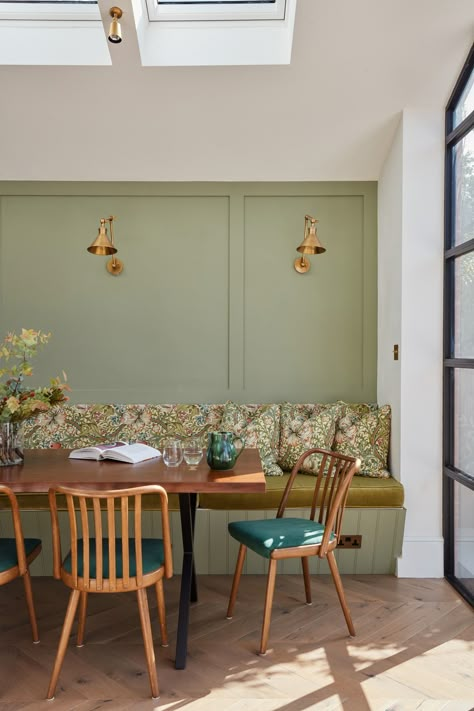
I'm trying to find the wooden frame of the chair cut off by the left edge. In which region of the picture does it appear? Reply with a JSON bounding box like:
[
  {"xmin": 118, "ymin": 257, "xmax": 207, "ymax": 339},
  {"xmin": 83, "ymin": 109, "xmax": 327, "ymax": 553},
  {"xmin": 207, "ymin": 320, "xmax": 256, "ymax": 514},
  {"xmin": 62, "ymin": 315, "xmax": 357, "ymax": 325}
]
[{"xmin": 0, "ymin": 484, "xmax": 41, "ymax": 644}]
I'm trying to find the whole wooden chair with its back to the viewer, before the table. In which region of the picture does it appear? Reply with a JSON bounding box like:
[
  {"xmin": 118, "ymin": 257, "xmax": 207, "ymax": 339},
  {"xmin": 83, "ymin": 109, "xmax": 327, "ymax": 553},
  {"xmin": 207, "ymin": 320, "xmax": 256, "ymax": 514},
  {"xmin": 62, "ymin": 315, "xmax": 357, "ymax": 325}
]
[{"xmin": 47, "ymin": 484, "xmax": 173, "ymax": 699}]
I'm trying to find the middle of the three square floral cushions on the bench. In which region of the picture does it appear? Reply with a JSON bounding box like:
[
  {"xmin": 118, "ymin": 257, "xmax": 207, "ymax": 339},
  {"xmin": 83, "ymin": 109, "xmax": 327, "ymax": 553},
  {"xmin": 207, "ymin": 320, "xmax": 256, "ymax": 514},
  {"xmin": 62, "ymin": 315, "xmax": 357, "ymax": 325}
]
[{"xmin": 278, "ymin": 402, "xmax": 341, "ymax": 474}]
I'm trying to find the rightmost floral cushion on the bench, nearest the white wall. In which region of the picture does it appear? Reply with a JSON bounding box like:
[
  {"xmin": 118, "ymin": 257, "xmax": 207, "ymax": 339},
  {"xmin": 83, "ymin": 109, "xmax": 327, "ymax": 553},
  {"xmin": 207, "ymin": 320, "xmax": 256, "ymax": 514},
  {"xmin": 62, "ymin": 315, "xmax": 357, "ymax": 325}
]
[{"xmin": 333, "ymin": 402, "xmax": 391, "ymax": 479}]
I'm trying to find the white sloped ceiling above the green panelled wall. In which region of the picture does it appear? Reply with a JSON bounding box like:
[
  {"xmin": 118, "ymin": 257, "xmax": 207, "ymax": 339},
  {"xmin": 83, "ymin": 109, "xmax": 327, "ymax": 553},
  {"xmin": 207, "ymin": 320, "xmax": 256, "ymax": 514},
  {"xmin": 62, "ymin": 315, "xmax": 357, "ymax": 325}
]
[{"xmin": 0, "ymin": 0, "xmax": 474, "ymax": 181}]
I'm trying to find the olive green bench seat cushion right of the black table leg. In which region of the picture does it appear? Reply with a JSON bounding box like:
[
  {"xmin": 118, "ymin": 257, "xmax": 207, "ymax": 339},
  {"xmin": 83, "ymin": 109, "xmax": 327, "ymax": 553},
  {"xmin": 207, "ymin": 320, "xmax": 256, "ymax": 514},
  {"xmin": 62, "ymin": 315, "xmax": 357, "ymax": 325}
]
[{"xmin": 199, "ymin": 474, "xmax": 404, "ymax": 511}]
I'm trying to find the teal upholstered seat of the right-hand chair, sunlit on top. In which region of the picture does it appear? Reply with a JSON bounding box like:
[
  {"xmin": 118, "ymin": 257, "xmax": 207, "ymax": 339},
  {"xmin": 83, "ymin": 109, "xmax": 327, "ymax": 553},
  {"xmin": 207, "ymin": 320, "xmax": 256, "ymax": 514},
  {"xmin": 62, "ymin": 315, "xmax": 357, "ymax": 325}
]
[{"xmin": 229, "ymin": 518, "xmax": 335, "ymax": 558}]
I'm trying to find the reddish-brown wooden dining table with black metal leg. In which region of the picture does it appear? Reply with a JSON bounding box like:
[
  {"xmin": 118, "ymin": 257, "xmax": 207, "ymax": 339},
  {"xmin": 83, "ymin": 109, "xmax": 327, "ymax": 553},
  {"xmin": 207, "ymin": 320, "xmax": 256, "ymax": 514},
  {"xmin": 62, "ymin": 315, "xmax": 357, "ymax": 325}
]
[{"xmin": 0, "ymin": 449, "xmax": 265, "ymax": 669}]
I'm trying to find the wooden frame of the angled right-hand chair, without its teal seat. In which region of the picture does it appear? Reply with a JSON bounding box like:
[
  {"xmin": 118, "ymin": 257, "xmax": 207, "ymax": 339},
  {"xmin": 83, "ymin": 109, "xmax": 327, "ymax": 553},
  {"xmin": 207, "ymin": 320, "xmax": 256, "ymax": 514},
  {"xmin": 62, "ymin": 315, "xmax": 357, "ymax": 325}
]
[{"xmin": 227, "ymin": 448, "xmax": 360, "ymax": 654}]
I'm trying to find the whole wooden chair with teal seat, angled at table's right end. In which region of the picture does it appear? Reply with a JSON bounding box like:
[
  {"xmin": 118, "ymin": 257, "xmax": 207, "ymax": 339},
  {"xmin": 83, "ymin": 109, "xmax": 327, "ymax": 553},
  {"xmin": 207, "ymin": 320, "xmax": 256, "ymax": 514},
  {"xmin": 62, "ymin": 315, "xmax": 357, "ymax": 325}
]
[{"xmin": 227, "ymin": 449, "xmax": 360, "ymax": 654}]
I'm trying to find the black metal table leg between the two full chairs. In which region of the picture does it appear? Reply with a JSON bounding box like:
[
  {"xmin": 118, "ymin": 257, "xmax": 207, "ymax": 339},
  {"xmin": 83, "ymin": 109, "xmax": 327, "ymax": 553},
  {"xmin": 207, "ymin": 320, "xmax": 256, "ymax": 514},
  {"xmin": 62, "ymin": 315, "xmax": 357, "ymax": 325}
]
[{"xmin": 175, "ymin": 494, "xmax": 197, "ymax": 669}]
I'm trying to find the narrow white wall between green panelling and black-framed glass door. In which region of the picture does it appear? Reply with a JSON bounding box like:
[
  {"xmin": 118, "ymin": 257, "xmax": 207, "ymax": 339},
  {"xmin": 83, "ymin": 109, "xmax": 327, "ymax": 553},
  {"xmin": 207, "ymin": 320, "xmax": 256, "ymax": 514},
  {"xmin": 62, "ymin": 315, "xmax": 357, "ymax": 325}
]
[{"xmin": 378, "ymin": 110, "xmax": 444, "ymax": 577}]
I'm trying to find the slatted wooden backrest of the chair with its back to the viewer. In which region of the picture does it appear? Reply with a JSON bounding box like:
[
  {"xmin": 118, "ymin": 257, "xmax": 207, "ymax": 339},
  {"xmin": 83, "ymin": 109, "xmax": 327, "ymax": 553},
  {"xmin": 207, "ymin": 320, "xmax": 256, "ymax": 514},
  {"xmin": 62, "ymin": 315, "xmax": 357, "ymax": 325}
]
[{"xmin": 49, "ymin": 484, "xmax": 173, "ymax": 592}]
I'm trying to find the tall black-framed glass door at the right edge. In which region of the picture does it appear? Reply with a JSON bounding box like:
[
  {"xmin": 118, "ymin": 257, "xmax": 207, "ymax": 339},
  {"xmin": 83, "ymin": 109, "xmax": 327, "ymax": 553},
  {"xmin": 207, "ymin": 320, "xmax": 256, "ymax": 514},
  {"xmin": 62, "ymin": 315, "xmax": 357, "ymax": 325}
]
[{"xmin": 443, "ymin": 41, "xmax": 474, "ymax": 604}]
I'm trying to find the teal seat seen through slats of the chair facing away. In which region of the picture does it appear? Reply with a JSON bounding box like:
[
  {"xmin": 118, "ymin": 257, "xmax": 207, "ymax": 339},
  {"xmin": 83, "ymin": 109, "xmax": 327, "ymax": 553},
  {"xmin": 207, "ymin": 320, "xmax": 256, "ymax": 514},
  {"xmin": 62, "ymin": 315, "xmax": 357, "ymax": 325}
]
[{"xmin": 64, "ymin": 538, "xmax": 165, "ymax": 578}]
